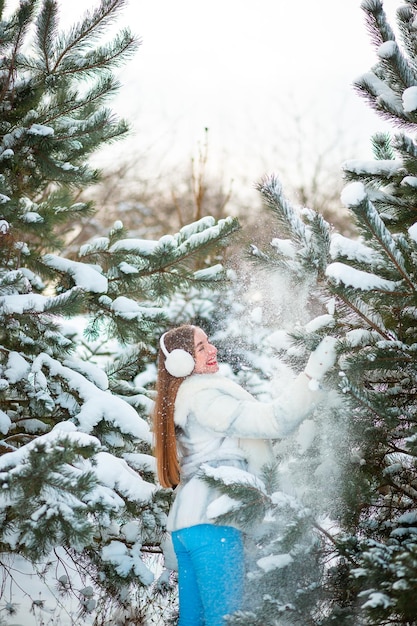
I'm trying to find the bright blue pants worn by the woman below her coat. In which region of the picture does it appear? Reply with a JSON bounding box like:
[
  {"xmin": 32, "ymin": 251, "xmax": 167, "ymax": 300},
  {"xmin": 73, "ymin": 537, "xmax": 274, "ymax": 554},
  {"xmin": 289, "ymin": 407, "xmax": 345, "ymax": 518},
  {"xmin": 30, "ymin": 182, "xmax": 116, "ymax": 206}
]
[{"xmin": 172, "ymin": 524, "xmax": 244, "ymax": 626}]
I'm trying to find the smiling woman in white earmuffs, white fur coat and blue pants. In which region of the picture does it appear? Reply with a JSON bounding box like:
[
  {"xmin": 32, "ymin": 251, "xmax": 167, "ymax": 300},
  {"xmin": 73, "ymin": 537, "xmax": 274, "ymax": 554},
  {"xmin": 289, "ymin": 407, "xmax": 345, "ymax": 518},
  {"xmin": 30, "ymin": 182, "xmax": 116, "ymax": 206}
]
[{"xmin": 154, "ymin": 325, "xmax": 335, "ymax": 626}]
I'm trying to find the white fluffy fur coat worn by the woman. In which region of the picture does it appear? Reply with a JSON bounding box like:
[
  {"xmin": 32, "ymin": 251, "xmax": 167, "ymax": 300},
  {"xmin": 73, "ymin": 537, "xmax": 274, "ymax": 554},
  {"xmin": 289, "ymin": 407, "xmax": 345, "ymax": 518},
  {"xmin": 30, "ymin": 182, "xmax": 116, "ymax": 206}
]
[{"xmin": 167, "ymin": 374, "xmax": 318, "ymax": 531}]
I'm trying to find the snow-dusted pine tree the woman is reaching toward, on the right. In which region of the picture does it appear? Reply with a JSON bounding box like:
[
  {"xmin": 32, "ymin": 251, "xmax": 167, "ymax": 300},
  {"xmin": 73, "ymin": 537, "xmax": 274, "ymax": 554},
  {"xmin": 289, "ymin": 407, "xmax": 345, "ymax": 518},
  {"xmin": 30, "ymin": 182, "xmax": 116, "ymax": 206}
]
[{"xmin": 210, "ymin": 0, "xmax": 417, "ymax": 626}]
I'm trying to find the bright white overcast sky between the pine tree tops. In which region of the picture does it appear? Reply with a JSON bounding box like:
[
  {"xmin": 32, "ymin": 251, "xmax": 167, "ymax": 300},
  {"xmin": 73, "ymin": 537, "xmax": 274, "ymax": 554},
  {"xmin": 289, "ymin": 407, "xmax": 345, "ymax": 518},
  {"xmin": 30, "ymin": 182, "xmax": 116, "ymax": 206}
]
[{"xmin": 61, "ymin": 0, "xmax": 402, "ymax": 190}]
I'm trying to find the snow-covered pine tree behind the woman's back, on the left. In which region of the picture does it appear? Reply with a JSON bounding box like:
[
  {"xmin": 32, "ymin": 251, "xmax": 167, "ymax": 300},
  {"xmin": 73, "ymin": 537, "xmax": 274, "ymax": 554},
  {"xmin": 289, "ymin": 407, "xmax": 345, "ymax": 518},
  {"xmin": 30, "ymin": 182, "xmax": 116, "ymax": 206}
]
[{"xmin": 0, "ymin": 0, "xmax": 238, "ymax": 620}]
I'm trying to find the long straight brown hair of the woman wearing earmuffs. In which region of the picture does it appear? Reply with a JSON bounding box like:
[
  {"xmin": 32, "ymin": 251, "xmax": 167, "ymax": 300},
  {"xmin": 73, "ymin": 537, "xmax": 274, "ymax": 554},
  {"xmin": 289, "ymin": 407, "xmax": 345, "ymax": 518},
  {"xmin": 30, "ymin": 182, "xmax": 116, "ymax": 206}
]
[{"xmin": 153, "ymin": 324, "xmax": 195, "ymax": 487}]
